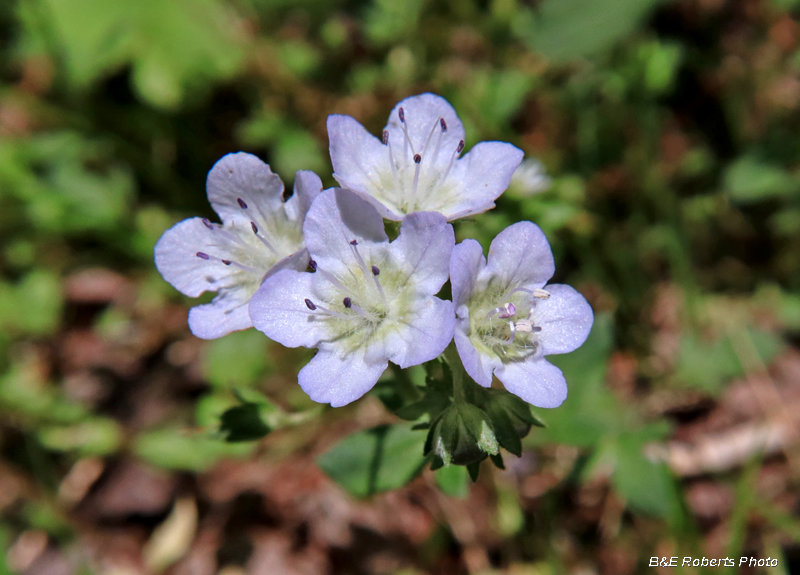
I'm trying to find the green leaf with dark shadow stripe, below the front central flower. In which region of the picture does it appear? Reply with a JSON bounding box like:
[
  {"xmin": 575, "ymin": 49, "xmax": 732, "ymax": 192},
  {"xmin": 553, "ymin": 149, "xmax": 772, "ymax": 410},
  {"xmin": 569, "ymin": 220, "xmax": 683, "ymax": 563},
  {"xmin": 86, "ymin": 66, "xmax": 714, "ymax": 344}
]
[{"xmin": 317, "ymin": 423, "xmax": 432, "ymax": 497}]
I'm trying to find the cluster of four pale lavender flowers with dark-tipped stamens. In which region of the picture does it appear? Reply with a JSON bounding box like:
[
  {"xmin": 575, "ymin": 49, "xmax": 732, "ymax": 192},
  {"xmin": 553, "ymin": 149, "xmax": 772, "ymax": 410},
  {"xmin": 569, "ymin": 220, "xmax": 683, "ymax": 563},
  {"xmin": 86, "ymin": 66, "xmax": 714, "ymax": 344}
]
[{"xmin": 155, "ymin": 94, "xmax": 593, "ymax": 414}]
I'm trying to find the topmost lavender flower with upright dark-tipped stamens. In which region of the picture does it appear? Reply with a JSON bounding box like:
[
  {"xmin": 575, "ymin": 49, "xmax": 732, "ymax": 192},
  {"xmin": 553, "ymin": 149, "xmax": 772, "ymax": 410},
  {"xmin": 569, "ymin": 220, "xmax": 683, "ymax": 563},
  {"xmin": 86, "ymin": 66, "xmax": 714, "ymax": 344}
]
[{"xmin": 328, "ymin": 94, "xmax": 523, "ymax": 221}]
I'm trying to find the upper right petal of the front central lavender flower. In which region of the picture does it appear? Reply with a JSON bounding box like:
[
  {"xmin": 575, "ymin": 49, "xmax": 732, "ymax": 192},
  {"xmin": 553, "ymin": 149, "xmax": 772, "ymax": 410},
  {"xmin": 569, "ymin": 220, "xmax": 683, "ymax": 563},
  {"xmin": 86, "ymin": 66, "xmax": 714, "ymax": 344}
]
[{"xmin": 389, "ymin": 212, "xmax": 456, "ymax": 295}]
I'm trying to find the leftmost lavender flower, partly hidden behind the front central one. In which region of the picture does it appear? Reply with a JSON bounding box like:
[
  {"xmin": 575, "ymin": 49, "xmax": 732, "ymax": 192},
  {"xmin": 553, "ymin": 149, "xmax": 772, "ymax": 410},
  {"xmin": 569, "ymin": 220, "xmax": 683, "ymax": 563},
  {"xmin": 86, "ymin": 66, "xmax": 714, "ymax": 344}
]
[{"xmin": 155, "ymin": 152, "xmax": 322, "ymax": 339}]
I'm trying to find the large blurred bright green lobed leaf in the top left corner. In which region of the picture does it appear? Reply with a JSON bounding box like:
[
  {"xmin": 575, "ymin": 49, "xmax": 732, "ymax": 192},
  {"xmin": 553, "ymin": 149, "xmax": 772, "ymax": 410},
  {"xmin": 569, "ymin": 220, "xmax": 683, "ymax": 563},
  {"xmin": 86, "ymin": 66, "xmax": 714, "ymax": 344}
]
[{"xmin": 33, "ymin": 0, "xmax": 244, "ymax": 108}]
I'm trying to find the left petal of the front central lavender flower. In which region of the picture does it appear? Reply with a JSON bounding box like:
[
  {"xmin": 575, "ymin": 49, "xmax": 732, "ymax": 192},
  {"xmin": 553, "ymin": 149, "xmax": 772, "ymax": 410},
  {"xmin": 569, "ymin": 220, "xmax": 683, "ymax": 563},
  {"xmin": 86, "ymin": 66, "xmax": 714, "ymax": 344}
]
[{"xmin": 250, "ymin": 270, "xmax": 327, "ymax": 347}]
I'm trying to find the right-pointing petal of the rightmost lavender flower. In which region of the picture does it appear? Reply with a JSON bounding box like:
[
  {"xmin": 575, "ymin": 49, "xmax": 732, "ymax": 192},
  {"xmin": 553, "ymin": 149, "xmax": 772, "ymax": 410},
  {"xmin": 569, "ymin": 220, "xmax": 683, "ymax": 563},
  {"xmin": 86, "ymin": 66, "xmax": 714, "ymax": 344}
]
[{"xmin": 533, "ymin": 284, "xmax": 594, "ymax": 355}]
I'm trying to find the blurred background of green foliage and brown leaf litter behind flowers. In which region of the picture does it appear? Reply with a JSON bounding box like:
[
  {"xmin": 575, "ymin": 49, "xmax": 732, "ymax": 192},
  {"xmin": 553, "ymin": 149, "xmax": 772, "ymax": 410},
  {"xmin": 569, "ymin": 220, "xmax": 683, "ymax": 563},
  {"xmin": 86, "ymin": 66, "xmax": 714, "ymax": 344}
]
[{"xmin": 0, "ymin": 0, "xmax": 800, "ymax": 575}]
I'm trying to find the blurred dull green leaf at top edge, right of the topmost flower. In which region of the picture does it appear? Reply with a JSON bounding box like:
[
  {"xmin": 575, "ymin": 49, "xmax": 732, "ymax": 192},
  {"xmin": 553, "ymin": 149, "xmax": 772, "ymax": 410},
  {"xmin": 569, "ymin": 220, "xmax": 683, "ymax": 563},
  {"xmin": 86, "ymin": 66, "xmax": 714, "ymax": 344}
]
[{"xmin": 513, "ymin": 0, "xmax": 663, "ymax": 62}]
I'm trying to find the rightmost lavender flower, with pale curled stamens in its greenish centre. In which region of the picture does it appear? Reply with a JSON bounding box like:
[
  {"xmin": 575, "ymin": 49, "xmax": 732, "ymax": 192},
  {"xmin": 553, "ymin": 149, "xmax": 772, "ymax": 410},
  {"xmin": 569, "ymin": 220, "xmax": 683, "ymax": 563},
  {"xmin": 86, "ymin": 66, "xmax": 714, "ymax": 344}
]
[{"xmin": 450, "ymin": 222, "xmax": 593, "ymax": 407}]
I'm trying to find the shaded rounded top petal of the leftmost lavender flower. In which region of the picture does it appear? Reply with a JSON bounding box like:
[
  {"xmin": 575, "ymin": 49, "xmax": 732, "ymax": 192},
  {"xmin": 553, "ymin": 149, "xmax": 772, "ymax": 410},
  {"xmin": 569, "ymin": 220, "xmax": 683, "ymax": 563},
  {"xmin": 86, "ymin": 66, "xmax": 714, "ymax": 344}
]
[{"xmin": 206, "ymin": 152, "xmax": 283, "ymax": 225}]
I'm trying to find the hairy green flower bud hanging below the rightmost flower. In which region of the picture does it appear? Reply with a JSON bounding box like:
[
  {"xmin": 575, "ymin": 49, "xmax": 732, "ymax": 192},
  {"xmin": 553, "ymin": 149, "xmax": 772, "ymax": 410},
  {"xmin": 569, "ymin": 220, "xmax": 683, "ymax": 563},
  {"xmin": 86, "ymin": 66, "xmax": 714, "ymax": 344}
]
[{"xmin": 426, "ymin": 403, "xmax": 500, "ymax": 465}]
